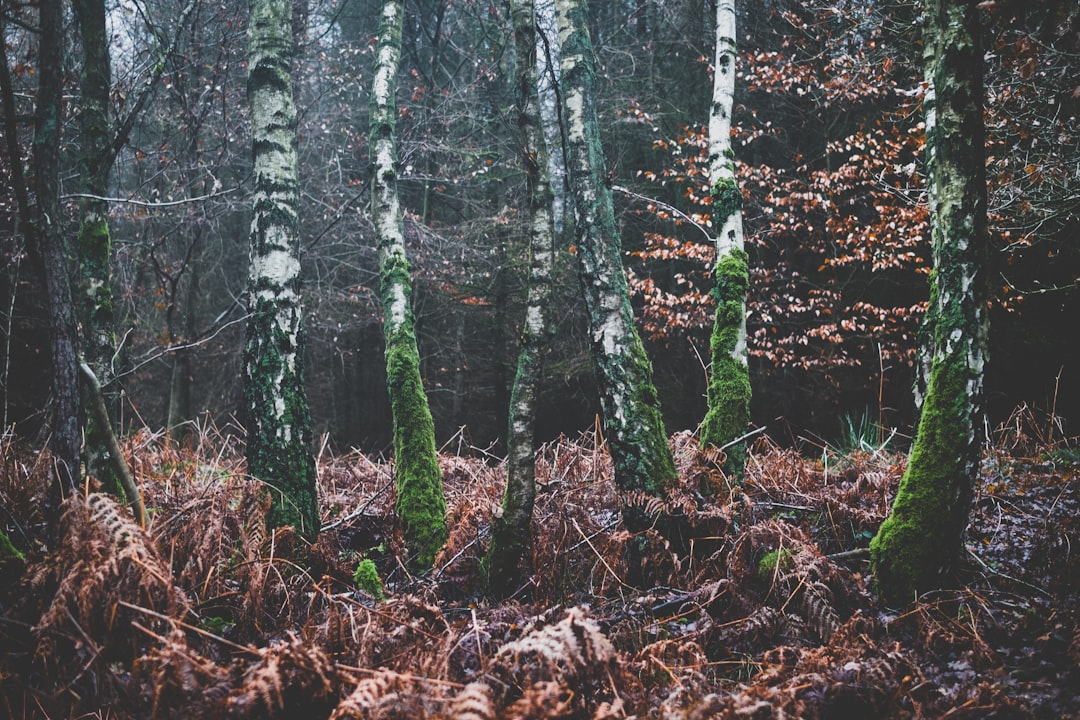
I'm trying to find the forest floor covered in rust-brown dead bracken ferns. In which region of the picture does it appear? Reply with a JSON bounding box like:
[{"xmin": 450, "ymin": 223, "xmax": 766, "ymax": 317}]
[{"xmin": 0, "ymin": 414, "xmax": 1080, "ymax": 720}]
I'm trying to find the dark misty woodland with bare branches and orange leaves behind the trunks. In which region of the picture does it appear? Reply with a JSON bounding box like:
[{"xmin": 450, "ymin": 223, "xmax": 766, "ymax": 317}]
[{"xmin": 0, "ymin": 0, "xmax": 1080, "ymax": 453}]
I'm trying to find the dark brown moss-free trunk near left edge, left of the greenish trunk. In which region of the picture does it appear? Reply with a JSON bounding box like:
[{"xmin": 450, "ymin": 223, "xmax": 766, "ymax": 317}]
[{"xmin": 33, "ymin": 0, "xmax": 80, "ymax": 512}]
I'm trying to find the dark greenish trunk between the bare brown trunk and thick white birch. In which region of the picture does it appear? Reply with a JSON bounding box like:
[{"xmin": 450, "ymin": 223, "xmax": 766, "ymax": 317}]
[{"xmin": 72, "ymin": 0, "xmax": 125, "ymax": 499}]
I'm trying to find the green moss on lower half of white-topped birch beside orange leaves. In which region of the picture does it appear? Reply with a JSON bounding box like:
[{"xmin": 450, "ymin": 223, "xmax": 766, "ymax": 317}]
[{"xmin": 701, "ymin": 247, "xmax": 751, "ymax": 477}]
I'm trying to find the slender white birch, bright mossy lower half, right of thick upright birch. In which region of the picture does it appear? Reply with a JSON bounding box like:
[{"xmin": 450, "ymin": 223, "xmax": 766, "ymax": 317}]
[{"xmin": 368, "ymin": 0, "xmax": 447, "ymax": 570}]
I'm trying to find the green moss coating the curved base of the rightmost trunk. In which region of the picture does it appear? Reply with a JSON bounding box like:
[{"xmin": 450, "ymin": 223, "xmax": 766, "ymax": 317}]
[{"xmin": 870, "ymin": 357, "xmax": 972, "ymax": 604}]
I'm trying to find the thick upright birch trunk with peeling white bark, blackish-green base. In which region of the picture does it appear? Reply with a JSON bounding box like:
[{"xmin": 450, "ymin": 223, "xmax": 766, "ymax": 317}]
[{"xmin": 244, "ymin": 0, "xmax": 319, "ymax": 538}]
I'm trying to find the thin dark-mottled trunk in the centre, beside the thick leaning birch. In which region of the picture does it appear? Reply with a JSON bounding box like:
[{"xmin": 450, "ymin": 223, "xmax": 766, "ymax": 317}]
[{"xmin": 485, "ymin": 0, "xmax": 555, "ymax": 595}]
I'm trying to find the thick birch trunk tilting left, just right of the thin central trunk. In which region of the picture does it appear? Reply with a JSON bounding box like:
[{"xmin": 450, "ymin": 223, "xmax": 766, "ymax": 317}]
[{"xmin": 556, "ymin": 0, "xmax": 675, "ymax": 507}]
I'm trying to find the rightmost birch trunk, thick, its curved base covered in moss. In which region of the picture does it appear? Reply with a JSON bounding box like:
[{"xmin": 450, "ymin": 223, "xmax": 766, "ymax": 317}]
[{"xmin": 870, "ymin": 0, "xmax": 988, "ymax": 603}]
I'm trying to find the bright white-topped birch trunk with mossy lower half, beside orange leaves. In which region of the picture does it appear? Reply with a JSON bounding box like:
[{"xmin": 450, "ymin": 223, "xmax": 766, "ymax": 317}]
[{"xmin": 701, "ymin": 0, "xmax": 751, "ymax": 477}]
